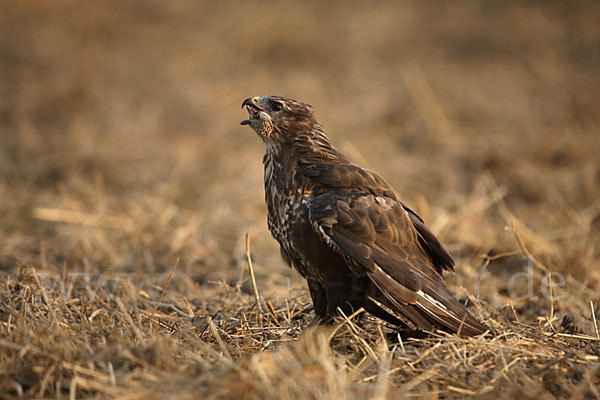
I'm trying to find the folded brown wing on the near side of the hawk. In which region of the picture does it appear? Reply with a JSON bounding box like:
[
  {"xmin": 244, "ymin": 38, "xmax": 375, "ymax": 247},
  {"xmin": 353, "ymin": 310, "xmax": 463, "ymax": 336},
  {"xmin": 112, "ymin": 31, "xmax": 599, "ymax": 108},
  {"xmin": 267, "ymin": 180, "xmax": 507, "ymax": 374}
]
[{"xmin": 310, "ymin": 189, "xmax": 486, "ymax": 335}]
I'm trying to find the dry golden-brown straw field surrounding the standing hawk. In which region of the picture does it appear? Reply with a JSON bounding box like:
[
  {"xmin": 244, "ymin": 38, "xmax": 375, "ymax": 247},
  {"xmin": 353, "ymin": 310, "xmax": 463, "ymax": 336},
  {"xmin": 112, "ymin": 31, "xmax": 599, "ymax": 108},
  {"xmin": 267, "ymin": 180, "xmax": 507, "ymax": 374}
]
[{"xmin": 0, "ymin": 0, "xmax": 600, "ymax": 400}]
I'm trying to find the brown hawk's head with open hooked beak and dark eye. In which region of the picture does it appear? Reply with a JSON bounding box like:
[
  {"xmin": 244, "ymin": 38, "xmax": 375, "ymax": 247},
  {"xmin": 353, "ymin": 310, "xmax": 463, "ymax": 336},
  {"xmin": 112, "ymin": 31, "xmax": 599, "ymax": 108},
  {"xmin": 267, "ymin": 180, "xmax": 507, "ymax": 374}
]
[{"xmin": 242, "ymin": 96, "xmax": 317, "ymax": 143}]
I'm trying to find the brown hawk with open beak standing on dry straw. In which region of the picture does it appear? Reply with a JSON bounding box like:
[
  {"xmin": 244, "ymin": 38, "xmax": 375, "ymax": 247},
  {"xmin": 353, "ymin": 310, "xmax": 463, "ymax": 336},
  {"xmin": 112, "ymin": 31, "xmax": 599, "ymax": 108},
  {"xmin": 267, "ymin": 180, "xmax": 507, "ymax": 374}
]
[{"xmin": 241, "ymin": 96, "xmax": 487, "ymax": 336}]
